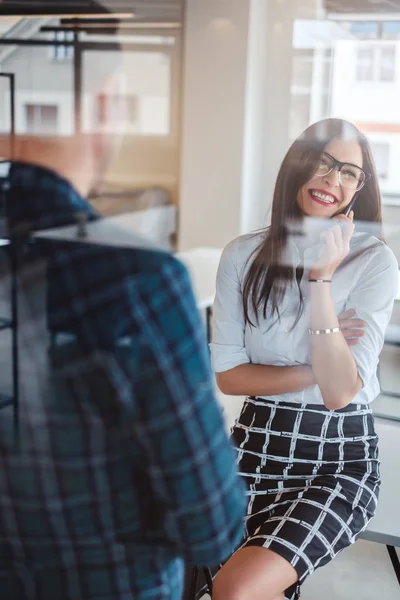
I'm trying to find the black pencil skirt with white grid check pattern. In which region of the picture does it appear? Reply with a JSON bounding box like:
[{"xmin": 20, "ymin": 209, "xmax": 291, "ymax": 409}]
[{"xmin": 232, "ymin": 398, "xmax": 380, "ymax": 600}]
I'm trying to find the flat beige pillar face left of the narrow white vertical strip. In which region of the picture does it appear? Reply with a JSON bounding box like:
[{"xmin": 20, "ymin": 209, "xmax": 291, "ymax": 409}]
[{"xmin": 179, "ymin": 0, "xmax": 251, "ymax": 249}]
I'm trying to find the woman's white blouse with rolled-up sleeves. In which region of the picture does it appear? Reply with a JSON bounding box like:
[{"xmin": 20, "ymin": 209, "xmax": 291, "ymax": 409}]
[{"xmin": 210, "ymin": 227, "xmax": 398, "ymax": 404}]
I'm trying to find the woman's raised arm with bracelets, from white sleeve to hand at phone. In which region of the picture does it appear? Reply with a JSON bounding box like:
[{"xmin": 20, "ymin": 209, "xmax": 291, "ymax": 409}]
[{"xmin": 310, "ymin": 218, "xmax": 398, "ymax": 410}]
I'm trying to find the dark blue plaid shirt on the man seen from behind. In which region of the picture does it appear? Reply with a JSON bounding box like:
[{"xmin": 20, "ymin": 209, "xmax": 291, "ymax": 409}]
[{"xmin": 0, "ymin": 163, "xmax": 245, "ymax": 600}]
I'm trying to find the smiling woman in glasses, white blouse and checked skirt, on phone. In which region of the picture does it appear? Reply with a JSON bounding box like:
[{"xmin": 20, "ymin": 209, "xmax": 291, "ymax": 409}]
[{"xmin": 211, "ymin": 119, "xmax": 398, "ymax": 600}]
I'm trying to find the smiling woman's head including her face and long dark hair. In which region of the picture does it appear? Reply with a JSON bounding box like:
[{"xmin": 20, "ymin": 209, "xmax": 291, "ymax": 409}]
[{"xmin": 239, "ymin": 119, "xmax": 382, "ymax": 328}]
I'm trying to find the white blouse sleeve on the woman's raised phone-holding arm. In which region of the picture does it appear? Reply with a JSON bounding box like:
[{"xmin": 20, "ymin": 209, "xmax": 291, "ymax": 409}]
[{"xmin": 346, "ymin": 245, "xmax": 399, "ymax": 387}]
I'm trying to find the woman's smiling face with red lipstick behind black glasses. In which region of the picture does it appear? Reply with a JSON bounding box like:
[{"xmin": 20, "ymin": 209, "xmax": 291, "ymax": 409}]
[{"xmin": 297, "ymin": 139, "xmax": 363, "ymax": 219}]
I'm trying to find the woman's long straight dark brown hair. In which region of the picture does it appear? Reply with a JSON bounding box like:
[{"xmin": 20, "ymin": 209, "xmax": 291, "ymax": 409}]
[{"xmin": 243, "ymin": 119, "xmax": 382, "ymax": 326}]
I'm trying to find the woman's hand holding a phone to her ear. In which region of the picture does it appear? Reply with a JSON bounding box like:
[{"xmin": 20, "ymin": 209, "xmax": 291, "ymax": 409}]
[{"xmin": 310, "ymin": 211, "xmax": 354, "ymax": 279}]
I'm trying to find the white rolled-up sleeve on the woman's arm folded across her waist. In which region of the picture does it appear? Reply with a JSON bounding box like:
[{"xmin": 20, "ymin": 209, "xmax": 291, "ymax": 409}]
[{"xmin": 210, "ymin": 240, "xmax": 250, "ymax": 373}]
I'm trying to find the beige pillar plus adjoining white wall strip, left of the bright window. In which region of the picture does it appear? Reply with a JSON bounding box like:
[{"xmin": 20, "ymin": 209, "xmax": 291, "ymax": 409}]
[{"xmin": 180, "ymin": 0, "xmax": 324, "ymax": 249}]
